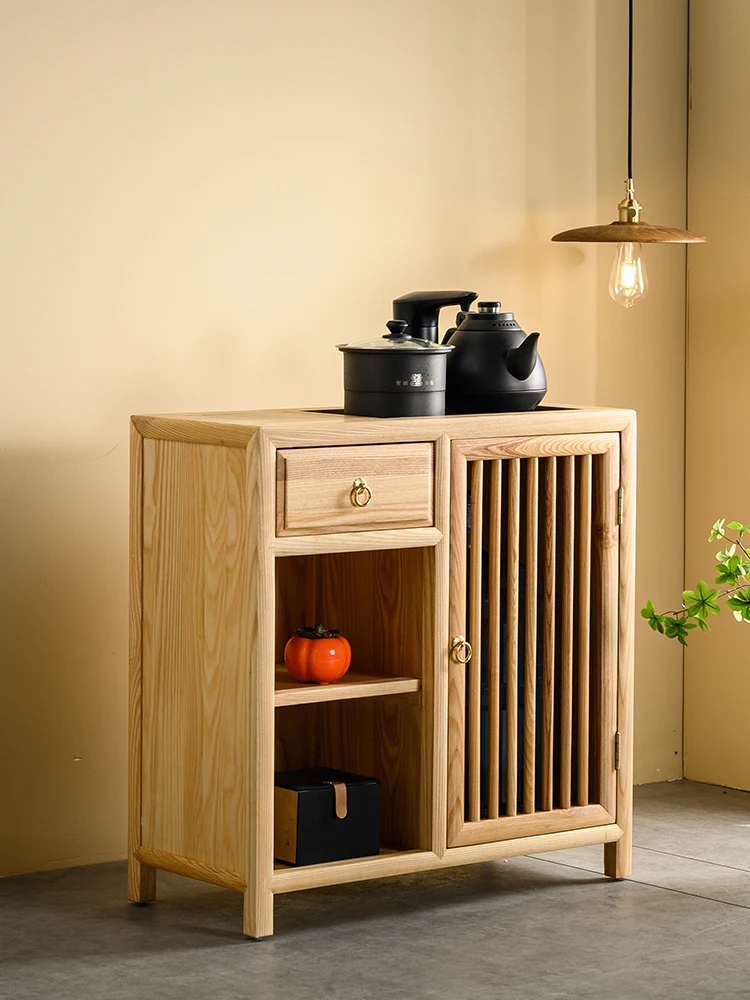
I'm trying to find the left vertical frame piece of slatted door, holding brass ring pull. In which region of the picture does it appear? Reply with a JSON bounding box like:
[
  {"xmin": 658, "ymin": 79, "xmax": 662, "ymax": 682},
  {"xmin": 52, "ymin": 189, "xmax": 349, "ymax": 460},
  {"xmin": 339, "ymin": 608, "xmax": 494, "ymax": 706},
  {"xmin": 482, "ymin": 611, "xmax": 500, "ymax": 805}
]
[{"xmin": 447, "ymin": 442, "xmax": 467, "ymax": 846}]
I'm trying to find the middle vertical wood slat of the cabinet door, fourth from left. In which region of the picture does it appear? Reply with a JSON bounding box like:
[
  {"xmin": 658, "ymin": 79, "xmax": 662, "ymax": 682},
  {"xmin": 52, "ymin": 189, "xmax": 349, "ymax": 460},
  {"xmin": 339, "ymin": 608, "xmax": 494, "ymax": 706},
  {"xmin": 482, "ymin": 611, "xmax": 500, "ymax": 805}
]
[{"xmin": 523, "ymin": 458, "xmax": 539, "ymax": 813}]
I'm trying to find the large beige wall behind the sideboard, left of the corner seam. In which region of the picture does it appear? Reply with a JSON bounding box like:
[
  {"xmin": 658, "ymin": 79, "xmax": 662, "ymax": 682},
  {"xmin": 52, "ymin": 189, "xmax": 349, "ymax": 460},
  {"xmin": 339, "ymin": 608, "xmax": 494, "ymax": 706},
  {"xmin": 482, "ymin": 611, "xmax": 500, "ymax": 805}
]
[{"xmin": 0, "ymin": 0, "xmax": 686, "ymax": 872}]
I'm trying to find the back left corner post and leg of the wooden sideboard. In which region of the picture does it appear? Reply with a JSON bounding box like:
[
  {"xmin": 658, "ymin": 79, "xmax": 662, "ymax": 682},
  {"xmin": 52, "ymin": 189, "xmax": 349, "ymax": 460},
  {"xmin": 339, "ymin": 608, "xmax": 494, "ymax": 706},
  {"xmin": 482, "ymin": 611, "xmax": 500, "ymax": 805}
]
[{"xmin": 128, "ymin": 423, "xmax": 156, "ymax": 903}]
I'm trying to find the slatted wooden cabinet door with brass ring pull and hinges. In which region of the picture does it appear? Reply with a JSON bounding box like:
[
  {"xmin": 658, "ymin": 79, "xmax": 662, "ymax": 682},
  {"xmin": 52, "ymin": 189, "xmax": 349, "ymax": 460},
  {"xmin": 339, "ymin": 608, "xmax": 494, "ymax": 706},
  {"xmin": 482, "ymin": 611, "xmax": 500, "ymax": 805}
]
[{"xmin": 448, "ymin": 434, "xmax": 620, "ymax": 847}]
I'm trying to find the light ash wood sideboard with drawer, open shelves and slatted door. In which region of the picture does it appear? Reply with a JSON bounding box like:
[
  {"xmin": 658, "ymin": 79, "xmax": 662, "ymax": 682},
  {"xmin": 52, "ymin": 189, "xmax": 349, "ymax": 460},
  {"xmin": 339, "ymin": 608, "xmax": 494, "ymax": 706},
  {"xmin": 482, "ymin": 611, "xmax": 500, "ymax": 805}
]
[{"xmin": 128, "ymin": 407, "xmax": 635, "ymax": 938}]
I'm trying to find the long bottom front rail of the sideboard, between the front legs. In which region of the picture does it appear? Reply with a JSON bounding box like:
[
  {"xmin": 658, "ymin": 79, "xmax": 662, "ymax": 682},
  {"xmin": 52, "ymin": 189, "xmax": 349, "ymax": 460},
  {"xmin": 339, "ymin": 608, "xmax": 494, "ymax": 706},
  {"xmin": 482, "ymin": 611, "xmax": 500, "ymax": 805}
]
[{"xmin": 272, "ymin": 823, "xmax": 622, "ymax": 893}]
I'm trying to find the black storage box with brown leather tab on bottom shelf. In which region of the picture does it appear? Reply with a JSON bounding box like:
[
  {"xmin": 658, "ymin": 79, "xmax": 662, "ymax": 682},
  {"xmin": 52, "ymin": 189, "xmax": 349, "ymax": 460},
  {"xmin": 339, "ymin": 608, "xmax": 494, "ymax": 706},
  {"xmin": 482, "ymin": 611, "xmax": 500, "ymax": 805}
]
[{"xmin": 273, "ymin": 767, "xmax": 380, "ymax": 865}]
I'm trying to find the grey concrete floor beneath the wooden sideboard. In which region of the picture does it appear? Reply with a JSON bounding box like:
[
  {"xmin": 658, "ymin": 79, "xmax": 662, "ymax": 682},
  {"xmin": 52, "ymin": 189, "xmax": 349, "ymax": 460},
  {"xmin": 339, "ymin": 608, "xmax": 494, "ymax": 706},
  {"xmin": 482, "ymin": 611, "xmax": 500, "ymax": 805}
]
[{"xmin": 0, "ymin": 781, "xmax": 750, "ymax": 1000}]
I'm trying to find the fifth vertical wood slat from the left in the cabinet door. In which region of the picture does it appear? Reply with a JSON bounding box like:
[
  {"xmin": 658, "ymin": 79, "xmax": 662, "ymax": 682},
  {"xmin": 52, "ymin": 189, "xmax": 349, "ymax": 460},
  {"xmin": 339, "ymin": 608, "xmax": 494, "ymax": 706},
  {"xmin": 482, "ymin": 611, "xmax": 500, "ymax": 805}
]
[{"xmin": 542, "ymin": 458, "xmax": 557, "ymax": 811}]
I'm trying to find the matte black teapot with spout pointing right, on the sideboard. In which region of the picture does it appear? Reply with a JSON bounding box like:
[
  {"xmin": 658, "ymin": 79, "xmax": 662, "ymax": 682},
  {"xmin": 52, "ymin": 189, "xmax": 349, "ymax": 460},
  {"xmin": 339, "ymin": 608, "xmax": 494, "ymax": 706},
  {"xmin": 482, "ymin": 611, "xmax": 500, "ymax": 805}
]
[{"xmin": 443, "ymin": 302, "xmax": 547, "ymax": 413}]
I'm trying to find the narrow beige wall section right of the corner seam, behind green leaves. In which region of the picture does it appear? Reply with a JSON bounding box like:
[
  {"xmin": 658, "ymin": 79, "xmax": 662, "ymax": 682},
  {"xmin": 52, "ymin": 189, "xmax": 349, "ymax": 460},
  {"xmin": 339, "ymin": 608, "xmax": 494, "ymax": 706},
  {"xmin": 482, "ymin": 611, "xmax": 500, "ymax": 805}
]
[{"xmin": 685, "ymin": 0, "xmax": 750, "ymax": 789}]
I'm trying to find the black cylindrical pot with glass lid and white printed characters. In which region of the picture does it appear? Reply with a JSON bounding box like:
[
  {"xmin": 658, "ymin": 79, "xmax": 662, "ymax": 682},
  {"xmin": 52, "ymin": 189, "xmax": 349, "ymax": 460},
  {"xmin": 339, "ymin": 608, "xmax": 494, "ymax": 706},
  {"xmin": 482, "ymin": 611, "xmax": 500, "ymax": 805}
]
[{"xmin": 337, "ymin": 319, "xmax": 453, "ymax": 417}]
